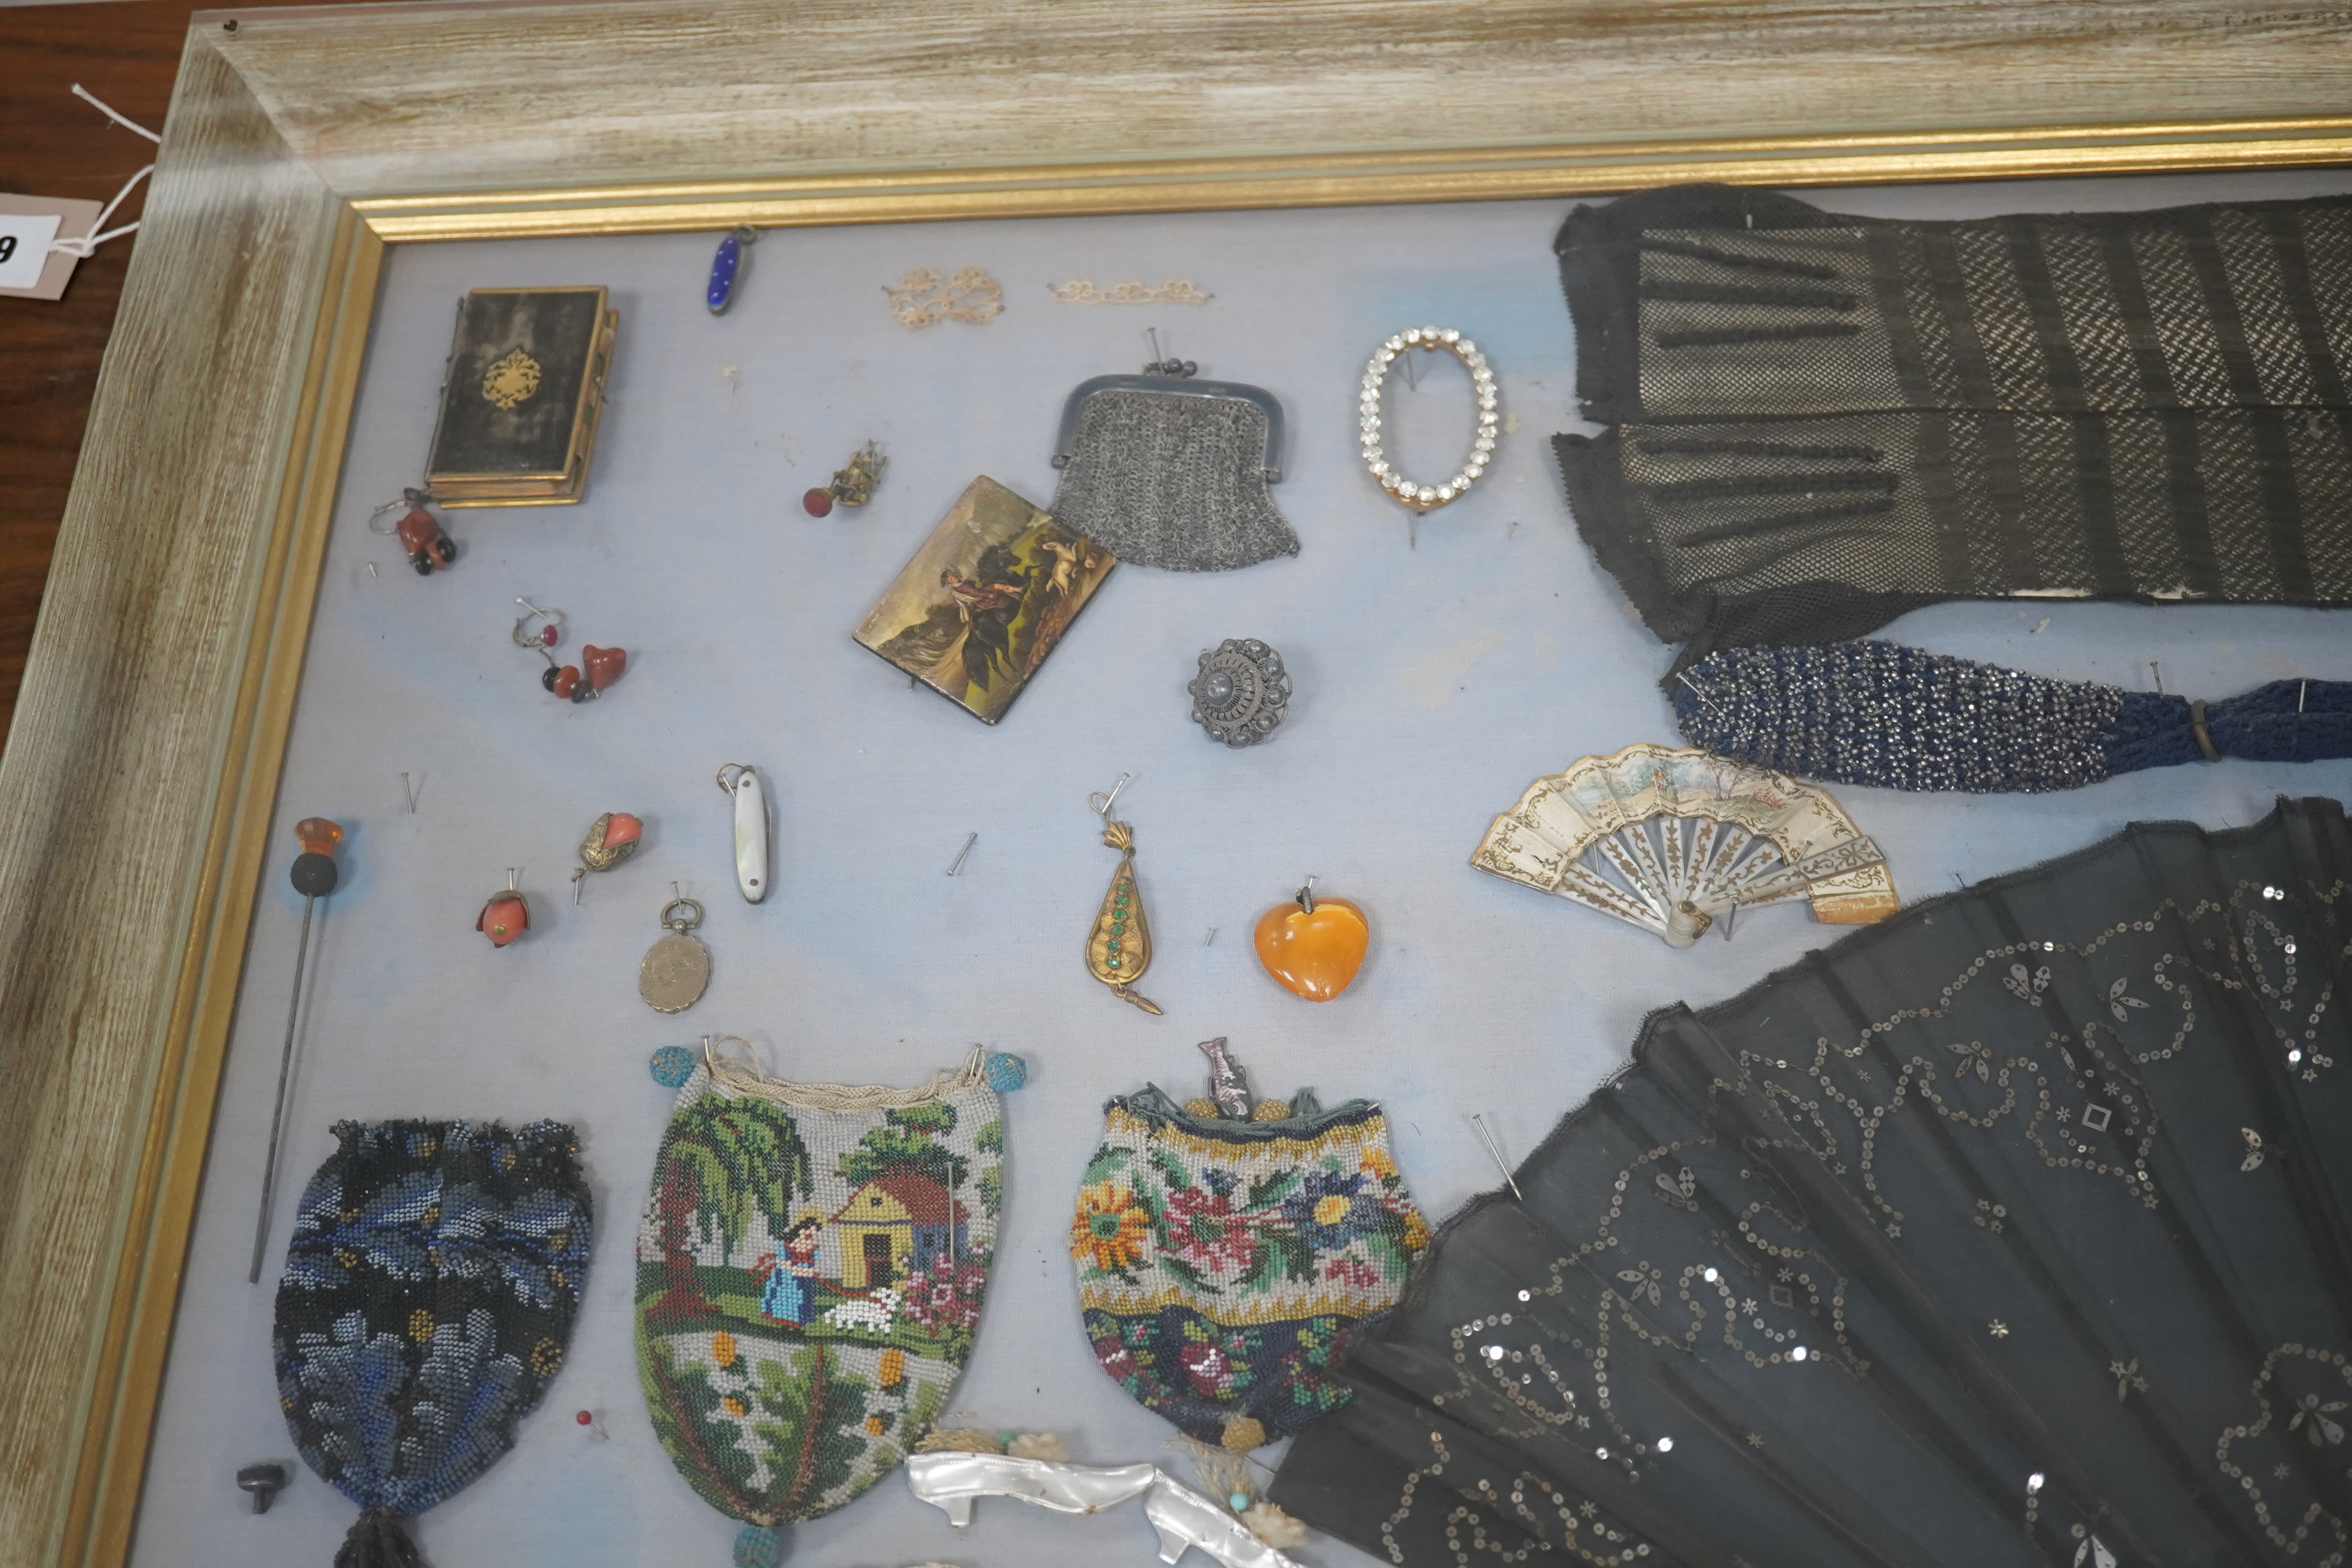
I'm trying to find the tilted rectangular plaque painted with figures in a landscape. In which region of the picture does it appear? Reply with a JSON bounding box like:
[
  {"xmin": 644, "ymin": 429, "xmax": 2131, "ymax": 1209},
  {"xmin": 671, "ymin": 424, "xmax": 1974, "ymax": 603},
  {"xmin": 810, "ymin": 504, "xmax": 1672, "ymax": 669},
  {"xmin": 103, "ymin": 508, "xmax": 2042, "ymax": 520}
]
[{"xmin": 856, "ymin": 475, "xmax": 1117, "ymax": 724}]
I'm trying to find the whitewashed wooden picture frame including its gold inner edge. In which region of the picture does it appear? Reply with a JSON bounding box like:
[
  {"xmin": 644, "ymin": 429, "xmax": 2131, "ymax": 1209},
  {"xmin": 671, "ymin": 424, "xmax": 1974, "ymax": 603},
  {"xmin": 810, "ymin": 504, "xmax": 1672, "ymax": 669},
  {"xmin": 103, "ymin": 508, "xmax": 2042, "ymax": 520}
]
[{"xmin": 0, "ymin": 0, "xmax": 2352, "ymax": 1568}]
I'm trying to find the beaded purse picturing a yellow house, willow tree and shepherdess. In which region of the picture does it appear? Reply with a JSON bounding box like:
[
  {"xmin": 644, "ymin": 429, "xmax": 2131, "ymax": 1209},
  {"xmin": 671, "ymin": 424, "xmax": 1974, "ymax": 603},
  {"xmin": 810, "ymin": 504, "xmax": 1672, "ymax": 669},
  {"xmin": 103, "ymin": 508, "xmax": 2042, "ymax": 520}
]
[{"xmin": 638, "ymin": 1034, "xmax": 1018, "ymax": 1561}]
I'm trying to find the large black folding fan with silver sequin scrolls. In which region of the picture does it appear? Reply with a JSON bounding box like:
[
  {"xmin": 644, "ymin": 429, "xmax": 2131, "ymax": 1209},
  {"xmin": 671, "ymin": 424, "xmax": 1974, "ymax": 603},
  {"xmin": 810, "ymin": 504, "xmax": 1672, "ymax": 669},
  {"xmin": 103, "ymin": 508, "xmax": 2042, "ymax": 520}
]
[{"xmin": 1272, "ymin": 800, "xmax": 2352, "ymax": 1568}]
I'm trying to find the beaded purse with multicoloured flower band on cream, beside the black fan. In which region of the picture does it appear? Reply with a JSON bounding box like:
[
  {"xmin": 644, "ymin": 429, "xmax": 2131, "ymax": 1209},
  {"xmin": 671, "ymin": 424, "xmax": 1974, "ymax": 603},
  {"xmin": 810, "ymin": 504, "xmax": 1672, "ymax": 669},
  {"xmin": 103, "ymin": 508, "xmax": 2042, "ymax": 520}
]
[{"xmin": 1070, "ymin": 1086, "xmax": 1430, "ymax": 1453}]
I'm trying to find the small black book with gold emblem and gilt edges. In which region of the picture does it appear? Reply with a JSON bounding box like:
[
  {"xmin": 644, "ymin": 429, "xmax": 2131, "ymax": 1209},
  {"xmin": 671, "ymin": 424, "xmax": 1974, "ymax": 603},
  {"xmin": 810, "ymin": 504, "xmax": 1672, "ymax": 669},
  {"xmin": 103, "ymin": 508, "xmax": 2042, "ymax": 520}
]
[{"xmin": 425, "ymin": 284, "xmax": 621, "ymax": 506}]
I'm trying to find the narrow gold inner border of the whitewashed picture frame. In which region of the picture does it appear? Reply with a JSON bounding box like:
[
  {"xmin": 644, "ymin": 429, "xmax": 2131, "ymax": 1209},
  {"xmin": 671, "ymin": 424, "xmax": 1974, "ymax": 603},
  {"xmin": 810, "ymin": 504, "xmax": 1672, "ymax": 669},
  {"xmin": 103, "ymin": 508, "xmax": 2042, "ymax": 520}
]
[{"xmin": 64, "ymin": 115, "xmax": 2352, "ymax": 1568}]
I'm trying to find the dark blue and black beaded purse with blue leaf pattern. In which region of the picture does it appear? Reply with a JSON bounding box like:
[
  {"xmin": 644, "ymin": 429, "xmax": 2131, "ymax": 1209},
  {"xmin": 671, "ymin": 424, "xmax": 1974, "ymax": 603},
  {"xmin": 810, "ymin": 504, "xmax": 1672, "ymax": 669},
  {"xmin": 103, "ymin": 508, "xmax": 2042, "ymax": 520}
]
[{"xmin": 271, "ymin": 1122, "xmax": 588, "ymax": 1568}]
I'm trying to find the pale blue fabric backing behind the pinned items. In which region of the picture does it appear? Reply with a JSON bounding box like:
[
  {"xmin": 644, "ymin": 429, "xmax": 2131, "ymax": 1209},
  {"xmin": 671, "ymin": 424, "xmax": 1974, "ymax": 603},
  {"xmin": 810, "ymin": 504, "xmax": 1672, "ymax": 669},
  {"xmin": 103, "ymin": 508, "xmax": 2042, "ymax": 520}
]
[{"xmin": 134, "ymin": 172, "xmax": 2352, "ymax": 1568}]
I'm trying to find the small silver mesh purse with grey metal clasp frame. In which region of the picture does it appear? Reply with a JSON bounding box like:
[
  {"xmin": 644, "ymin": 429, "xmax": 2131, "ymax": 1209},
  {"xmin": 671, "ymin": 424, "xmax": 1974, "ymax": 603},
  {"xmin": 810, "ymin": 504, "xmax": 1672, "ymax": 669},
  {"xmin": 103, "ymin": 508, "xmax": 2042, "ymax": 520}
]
[{"xmin": 1054, "ymin": 374, "xmax": 1298, "ymax": 571}]
